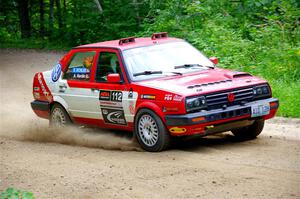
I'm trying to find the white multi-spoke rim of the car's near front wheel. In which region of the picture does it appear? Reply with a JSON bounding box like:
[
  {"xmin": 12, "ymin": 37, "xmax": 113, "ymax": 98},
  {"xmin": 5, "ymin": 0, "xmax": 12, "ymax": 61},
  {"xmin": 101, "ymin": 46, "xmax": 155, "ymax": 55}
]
[{"xmin": 138, "ymin": 115, "xmax": 158, "ymax": 147}]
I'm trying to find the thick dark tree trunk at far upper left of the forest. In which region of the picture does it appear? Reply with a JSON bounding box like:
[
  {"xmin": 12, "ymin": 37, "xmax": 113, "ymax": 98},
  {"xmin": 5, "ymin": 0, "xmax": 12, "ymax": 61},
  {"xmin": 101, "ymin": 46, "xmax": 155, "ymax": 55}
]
[{"xmin": 18, "ymin": 0, "xmax": 31, "ymax": 39}]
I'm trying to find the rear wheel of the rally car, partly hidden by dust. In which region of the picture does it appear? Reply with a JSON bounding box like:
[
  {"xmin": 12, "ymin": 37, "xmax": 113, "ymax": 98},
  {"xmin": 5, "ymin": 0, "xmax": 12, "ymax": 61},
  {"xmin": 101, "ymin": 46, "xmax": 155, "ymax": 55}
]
[{"xmin": 49, "ymin": 103, "xmax": 72, "ymax": 128}]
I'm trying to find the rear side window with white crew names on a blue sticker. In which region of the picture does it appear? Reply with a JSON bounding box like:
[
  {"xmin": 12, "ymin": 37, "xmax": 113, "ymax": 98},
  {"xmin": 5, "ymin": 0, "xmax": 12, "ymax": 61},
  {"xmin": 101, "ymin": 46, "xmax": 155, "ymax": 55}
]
[{"xmin": 64, "ymin": 52, "xmax": 96, "ymax": 81}]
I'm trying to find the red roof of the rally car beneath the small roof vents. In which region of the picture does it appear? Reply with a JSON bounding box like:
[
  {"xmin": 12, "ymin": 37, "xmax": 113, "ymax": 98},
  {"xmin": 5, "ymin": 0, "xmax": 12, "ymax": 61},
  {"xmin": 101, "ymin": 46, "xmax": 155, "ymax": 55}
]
[{"xmin": 75, "ymin": 37, "xmax": 183, "ymax": 50}]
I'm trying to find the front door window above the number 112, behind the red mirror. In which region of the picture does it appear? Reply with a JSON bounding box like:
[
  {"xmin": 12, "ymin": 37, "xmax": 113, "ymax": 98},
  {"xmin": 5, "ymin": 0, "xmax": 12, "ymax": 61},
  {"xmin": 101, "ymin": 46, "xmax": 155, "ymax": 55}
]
[{"xmin": 95, "ymin": 52, "xmax": 122, "ymax": 82}]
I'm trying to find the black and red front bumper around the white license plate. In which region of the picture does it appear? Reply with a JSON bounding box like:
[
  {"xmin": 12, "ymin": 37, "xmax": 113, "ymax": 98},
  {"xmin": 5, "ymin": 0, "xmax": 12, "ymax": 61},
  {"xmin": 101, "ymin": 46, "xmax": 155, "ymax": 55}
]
[{"xmin": 165, "ymin": 98, "xmax": 279, "ymax": 135}]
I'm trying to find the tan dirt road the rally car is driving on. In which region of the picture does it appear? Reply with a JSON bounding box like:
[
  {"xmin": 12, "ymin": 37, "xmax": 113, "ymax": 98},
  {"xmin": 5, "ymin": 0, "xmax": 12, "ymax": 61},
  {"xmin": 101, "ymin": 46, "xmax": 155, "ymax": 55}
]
[{"xmin": 0, "ymin": 50, "xmax": 300, "ymax": 198}]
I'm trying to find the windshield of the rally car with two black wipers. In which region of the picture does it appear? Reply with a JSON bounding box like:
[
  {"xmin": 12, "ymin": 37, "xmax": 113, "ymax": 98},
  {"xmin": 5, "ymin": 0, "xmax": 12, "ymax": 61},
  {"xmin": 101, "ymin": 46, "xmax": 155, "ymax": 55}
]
[{"xmin": 123, "ymin": 41, "xmax": 214, "ymax": 81}]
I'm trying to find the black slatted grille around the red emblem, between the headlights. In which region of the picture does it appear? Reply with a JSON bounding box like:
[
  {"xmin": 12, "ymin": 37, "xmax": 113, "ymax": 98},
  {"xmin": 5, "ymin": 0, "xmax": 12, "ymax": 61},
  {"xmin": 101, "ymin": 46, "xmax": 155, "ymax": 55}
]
[{"xmin": 205, "ymin": 87, "xmax": 254, "ymax": 110}]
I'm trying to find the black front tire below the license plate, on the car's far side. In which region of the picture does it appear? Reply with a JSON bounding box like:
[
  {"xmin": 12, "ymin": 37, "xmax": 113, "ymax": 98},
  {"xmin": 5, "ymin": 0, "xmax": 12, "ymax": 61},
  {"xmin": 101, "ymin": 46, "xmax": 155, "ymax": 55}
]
[{"xmin": 231, "ymin": 119, "xmax": 265, "ymax": 140}]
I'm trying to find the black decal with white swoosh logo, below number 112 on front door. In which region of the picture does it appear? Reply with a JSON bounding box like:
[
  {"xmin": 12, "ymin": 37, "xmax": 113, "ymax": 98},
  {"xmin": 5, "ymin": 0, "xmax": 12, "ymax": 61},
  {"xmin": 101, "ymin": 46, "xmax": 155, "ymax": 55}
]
[{"xmin": 101, "ymin": 108, "xmax": 127, "ymax": 125}]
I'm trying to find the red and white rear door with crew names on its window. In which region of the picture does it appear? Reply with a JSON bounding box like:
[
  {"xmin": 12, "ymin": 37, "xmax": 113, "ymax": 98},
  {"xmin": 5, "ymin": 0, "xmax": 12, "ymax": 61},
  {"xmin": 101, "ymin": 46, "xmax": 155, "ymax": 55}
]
[{"xmin": 57, "ymin": 49, "xmax": 101, "ymax": 120}]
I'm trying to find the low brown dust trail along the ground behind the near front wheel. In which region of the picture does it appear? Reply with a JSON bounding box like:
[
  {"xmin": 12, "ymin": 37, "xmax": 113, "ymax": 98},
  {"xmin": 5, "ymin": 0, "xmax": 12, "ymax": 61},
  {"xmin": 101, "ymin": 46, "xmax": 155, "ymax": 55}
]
[{"xmin": 0, "ymin": 116, "xmax": 142, "ymax": 151}]
